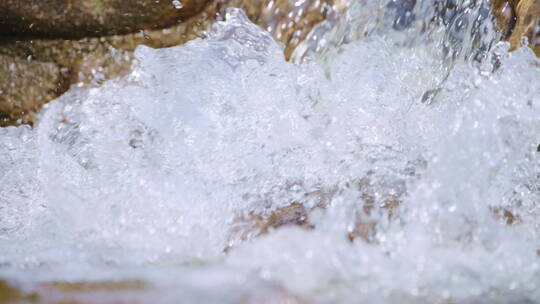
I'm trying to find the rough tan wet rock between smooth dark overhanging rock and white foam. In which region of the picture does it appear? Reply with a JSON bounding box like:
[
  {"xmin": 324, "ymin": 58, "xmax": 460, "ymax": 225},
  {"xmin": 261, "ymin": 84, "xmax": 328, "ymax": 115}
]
[{"xmin": 0, "ymin": 0, "xmax": 218, "ymax": 126}]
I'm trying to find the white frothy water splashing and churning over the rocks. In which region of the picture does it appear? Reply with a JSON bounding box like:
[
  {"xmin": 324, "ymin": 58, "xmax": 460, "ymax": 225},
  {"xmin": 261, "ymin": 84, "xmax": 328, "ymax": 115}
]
[{"xmin": 0, "ymin": 0, "xmax": 540, "ymax": 303}]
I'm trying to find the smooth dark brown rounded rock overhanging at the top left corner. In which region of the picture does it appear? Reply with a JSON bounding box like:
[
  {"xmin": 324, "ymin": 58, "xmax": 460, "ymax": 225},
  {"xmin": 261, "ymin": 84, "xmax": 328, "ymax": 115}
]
[{"xmin": 0, "ymin": 0, "xmax": 210, "ymax": 38}]
